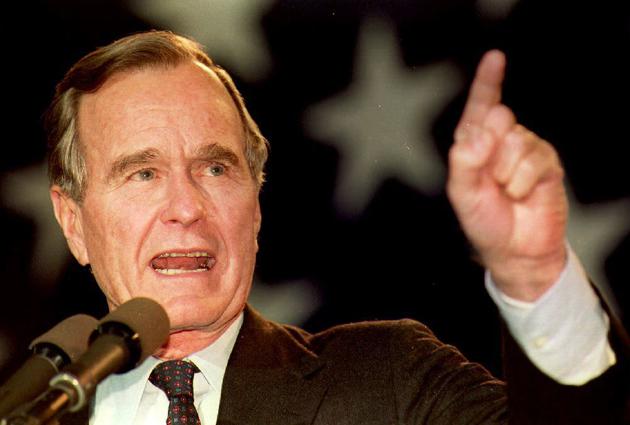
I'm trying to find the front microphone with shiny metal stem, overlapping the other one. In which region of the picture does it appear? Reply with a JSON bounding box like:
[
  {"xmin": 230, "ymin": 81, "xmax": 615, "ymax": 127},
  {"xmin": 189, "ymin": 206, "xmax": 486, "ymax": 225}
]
[{"xmin": 0, "ymin": 298, "xmax": 170, "ymax": 425}]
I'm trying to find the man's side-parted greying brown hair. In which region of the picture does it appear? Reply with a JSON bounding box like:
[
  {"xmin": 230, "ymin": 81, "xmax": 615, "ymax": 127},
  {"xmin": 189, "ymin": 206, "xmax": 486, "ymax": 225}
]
[{"xmin": 45, "ymin": 31, "xmax": 268, "ymax": 202}]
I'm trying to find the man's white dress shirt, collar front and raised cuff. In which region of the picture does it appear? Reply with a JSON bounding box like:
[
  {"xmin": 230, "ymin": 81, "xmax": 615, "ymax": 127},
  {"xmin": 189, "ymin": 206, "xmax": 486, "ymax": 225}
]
[{"xmin": 90, "ymin": 252, "xmax": 615, "ymax": 425}]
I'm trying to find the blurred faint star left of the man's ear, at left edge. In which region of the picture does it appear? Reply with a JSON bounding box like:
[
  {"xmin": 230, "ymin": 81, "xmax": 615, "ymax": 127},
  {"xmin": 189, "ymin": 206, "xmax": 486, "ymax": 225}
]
[{"xmin": 2, "ymin": 162, "xmax": 70, "ymax": 289}]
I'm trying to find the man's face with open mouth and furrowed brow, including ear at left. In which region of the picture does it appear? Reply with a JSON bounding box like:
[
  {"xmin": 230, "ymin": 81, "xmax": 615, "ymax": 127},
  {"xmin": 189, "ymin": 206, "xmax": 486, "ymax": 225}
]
[{"xmin": 53, "ymin": 63, "xmax": 261, "ymax": 330}]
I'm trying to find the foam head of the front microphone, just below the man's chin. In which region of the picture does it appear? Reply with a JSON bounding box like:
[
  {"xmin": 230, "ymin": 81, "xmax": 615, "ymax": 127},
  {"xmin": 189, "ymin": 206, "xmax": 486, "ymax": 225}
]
[{"xmin": 90, "ymin": 298, "xmax": 170, "ymax": 369}]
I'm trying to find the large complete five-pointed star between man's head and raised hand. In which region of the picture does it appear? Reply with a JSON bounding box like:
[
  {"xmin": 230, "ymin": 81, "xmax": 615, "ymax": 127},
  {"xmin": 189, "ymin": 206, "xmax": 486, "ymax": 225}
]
[{"xmin": 305, "ymin": 17, "xmax": 462, "ymax": 215}]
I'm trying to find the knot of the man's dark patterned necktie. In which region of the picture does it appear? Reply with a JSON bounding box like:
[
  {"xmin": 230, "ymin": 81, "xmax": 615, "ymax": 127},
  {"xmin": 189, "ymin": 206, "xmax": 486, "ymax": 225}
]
[{"xmin": 149, "ymin": 360, "xmax": 199, "ymax": 400}]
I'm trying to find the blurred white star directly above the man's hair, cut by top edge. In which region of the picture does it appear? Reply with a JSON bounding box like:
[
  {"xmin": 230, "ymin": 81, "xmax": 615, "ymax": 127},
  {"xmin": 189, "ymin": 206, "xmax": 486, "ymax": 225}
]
[{"xmin": 130, "ymin": 0, "xmax": 272, "ymax": 81}]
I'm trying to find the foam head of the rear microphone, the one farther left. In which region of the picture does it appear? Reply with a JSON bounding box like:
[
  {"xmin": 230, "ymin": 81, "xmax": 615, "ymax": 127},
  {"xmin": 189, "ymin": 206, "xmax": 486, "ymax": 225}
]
[{"xmin": 29, "ymin": 314, "xmax": 98, "ymax": 362}]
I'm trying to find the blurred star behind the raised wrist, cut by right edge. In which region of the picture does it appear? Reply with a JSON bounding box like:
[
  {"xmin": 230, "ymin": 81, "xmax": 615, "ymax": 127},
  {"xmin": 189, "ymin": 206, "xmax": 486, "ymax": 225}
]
[{"xmin": 567, "ymin": 186, "xmax": 630, "ymax": 311}]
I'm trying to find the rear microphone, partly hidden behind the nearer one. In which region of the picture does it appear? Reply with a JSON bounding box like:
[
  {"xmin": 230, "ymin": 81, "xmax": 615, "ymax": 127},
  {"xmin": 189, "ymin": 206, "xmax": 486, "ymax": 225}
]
[{"xmin": 0, "ymin": 314, "xmax": 97, "ymax": 418}]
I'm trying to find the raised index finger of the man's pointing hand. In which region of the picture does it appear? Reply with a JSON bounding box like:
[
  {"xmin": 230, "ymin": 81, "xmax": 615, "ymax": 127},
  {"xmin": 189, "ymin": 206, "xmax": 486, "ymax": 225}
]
[{"xmin": 459, "ymin": 50, "xmax": 505, "ymax": 126}]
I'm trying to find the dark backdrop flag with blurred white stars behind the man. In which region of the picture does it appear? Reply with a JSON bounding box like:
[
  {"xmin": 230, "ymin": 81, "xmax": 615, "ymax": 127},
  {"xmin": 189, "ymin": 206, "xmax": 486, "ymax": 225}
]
[{"xmin": 0, "ymin": 0, "xmax": 630, "ymax": 380}]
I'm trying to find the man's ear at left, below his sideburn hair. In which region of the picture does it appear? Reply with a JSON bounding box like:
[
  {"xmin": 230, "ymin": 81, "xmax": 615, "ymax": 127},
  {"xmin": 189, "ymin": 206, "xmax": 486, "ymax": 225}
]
[{"xmin": 50, "ymin": 185, "xmax": 90, "ymax": 266}]
